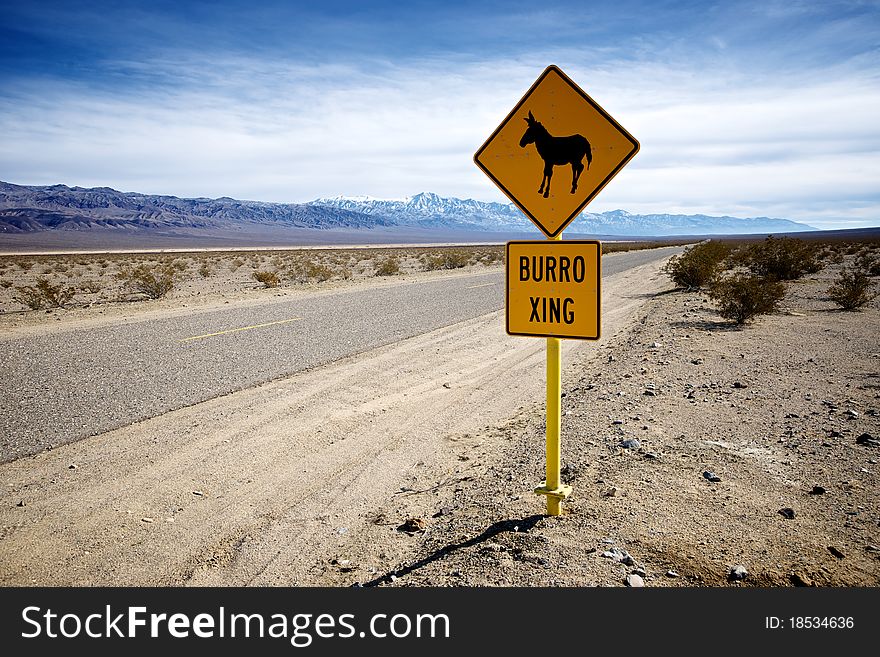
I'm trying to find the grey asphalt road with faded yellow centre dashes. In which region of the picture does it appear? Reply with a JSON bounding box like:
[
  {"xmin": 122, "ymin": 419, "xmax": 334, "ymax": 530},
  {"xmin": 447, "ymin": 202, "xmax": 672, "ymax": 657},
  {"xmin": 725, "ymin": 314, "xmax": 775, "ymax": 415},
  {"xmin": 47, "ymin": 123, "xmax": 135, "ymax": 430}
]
[{"xmin": 0, "ymin": 247, "xmax": 676, "ymax": 462}]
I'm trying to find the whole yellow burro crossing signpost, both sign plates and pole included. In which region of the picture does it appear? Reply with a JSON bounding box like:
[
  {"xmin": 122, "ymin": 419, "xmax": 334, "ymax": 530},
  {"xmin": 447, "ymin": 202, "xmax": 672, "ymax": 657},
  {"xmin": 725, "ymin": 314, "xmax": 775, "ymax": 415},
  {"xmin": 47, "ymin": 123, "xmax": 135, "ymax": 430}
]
[{"xmin": 474, "ymin": 66, "xmax": 639, "ymax": 516}]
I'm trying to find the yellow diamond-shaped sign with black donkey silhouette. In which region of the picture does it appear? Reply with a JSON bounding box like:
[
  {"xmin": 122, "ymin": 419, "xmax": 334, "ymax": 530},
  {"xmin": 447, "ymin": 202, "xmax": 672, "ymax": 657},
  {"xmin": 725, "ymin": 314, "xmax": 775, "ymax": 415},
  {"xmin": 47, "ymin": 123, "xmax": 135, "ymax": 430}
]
[{"xmin": 474, "ymin": 66, "xmax": 639, "ymax": 237}]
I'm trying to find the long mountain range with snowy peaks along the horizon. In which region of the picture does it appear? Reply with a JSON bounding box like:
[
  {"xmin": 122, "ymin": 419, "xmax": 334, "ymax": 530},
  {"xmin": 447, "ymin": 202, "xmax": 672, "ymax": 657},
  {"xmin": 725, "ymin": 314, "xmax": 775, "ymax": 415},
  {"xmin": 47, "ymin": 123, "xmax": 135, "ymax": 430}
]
[{"xmin": 0, "ymin": 182, "xmax": 814, "ymax": 236}]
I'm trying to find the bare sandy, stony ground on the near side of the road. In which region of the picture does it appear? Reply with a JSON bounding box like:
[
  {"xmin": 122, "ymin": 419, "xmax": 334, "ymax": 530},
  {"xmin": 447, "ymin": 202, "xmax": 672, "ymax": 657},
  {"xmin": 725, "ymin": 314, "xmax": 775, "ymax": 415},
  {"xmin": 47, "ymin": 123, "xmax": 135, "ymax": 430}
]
[{"xmin": 0, "ymin": 246, "xmax": 880, "ymax": 586}]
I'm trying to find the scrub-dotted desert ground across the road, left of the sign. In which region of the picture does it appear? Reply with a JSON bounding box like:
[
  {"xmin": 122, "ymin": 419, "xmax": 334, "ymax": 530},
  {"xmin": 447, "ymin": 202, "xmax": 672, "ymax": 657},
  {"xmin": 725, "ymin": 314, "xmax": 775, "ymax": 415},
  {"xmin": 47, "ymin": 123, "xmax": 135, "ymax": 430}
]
[{"xmin": 0, "ymin": 245, "xmax": 504, "ymax": 326}]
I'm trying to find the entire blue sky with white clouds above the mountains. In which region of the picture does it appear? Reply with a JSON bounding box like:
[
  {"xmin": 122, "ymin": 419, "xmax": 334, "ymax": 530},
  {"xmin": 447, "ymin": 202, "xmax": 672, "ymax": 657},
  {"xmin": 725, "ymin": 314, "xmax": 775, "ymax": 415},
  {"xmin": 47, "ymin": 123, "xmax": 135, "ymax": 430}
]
[{"xmin": 0, "ymin": 0, "xmax": 880, "ymax": 228}]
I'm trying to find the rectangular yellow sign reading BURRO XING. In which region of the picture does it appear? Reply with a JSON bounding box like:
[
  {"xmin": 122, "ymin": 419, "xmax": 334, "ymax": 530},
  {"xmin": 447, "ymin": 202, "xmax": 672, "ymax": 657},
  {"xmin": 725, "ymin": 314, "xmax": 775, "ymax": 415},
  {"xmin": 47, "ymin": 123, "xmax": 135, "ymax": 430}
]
[{"xmin": 506, "ymin": 240, "xmax": 602, "ymax": 340}]
